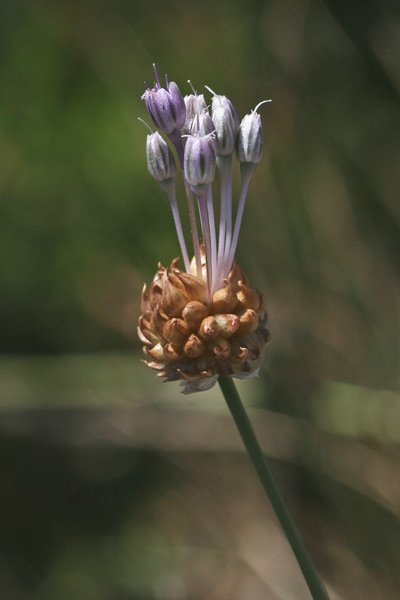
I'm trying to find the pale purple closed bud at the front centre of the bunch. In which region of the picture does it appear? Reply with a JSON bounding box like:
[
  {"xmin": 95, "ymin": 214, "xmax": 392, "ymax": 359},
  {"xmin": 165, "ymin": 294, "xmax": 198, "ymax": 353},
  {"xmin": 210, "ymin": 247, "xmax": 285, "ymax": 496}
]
[{"xmin": 184, "ymin": 134, "xmax": 216, "ymax": 194}]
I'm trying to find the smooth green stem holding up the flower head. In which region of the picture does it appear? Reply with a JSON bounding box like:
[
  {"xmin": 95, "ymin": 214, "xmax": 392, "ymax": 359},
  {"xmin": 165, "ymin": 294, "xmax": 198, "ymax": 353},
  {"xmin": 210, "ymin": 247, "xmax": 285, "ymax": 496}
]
[{"xmin": 218, "ymin": 377, "xmax": 329, "ymax": 600}]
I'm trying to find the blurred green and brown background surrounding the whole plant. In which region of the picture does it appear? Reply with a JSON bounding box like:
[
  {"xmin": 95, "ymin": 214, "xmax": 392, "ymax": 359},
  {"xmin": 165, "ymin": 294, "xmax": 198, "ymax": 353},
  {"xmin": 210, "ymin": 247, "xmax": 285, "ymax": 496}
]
[{"xmin": 0, "ymin": 0, "xmax": 400, "ymax": 600}]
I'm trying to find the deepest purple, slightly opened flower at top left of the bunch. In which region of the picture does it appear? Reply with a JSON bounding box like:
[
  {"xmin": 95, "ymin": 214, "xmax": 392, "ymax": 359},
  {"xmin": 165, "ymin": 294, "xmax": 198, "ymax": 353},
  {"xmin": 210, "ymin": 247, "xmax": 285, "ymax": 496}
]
[{"xmin": 142, "ymin": 67, "xmax": 186, "ymax": 135}]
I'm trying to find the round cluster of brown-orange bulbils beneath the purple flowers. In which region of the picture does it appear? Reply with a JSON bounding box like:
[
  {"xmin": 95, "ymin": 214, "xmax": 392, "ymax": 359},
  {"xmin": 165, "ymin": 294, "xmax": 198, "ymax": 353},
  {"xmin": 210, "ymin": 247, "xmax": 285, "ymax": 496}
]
[{"xmin": 138, "ymin": 259, "xmax": 270, "ymax": 389}]
